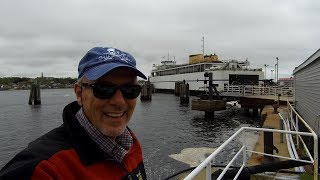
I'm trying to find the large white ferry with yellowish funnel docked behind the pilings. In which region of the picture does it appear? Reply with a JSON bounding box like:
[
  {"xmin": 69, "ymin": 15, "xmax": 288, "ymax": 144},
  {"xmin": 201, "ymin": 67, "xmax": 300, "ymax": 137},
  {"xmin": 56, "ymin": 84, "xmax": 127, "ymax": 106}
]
[{"xmin": 150, "ymin": 54, "xmax": 264, "ymax": 92}]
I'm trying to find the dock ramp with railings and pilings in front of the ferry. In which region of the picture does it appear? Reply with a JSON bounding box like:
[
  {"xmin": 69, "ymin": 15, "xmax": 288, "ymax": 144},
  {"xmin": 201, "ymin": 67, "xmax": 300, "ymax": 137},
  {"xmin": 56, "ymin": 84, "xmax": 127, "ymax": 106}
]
[{"xmin": 151, "ymin": 79, "xmax": 295, "ymax": 118}]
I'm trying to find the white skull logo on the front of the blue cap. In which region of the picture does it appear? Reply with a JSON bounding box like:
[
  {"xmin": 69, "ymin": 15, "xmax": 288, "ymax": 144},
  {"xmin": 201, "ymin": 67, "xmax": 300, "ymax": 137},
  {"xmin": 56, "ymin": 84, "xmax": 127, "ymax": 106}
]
[{"xmin": 98, "ymin": 48, "xmax": 132, "ymax": 64}]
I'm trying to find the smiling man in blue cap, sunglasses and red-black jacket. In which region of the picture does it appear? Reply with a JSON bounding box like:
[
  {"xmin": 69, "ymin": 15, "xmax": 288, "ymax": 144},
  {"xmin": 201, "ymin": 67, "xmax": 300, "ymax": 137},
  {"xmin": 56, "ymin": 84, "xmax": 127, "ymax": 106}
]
[{"xmin": 0, "ymin": 47, "xmax": 146, "ymax": 179}]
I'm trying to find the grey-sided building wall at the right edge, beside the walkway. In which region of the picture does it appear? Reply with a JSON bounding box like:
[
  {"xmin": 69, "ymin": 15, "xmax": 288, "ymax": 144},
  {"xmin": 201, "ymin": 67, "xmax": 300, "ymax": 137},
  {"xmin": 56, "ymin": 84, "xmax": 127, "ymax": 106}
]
[{"xmin": 293, "ymin": 49, "xmax": 320, "ymax": 136}]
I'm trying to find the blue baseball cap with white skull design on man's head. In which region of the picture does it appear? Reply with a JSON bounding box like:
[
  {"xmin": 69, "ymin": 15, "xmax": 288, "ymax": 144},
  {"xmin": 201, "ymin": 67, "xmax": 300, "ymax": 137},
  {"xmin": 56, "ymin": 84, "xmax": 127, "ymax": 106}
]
[{"xmin": 78, "ymin": 47, "xmax": 147, "ymax": 80}]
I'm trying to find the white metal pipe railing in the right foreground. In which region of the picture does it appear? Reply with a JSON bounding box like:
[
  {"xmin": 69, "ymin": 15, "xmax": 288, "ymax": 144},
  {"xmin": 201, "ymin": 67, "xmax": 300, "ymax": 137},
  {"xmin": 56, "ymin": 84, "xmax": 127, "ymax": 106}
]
[{"xmin": 185, "ymin": 102, "xmax": 318, "ymax": 180}]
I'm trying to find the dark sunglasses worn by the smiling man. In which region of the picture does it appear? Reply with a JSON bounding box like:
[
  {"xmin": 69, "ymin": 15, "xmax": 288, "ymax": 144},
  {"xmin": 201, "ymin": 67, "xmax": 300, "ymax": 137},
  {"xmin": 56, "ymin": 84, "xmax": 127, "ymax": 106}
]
[{"xmin": 81, "ymin": 83, "xmax": 141, "ymax": 99}]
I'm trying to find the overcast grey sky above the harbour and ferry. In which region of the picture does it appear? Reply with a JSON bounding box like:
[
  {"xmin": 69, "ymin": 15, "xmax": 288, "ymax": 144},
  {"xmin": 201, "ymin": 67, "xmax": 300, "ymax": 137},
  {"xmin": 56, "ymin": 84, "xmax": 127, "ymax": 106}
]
[{"xmin": 0, "ymin": 0, "xmax": 320, "ymax": 77}]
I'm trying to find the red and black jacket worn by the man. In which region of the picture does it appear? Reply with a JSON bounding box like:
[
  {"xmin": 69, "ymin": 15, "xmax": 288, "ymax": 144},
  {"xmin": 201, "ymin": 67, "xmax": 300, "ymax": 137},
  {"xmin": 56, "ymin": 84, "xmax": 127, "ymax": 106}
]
[{"xmin": 0, "ymin": 102, "xmax": 146, "ymax": 180}]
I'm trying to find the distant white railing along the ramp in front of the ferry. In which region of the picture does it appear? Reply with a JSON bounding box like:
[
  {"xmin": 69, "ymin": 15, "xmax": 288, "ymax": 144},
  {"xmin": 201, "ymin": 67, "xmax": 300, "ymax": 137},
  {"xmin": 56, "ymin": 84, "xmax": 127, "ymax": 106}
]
[{"xmin": 223, "ymin": 85, "xmax": 294, "ymax": 97}]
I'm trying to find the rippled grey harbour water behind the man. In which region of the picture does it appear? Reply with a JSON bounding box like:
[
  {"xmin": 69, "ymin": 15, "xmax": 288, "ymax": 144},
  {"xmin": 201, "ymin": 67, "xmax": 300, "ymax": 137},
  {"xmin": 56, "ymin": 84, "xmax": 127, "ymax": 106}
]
[{"xmin": 0, "ymin": 89, "xmax": 257, "ymax": 179}]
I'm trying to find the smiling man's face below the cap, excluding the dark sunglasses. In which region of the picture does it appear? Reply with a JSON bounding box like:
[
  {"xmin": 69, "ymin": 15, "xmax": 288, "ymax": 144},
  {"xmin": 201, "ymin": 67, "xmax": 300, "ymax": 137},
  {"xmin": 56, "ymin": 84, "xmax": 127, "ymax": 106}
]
[{"xmin": 75, "ymin": 68, "xmax": 137, "ymax": 139}]
